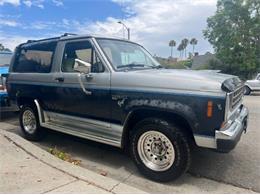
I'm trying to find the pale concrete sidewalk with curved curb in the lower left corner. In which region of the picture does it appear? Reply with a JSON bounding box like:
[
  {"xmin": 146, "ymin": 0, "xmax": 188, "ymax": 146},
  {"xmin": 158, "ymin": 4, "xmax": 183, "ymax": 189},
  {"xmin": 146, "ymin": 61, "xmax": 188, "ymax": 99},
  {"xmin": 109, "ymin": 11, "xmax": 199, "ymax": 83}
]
[{"xmin": 0, "ymin": 129, "xmax": 145, "ymax": 193}]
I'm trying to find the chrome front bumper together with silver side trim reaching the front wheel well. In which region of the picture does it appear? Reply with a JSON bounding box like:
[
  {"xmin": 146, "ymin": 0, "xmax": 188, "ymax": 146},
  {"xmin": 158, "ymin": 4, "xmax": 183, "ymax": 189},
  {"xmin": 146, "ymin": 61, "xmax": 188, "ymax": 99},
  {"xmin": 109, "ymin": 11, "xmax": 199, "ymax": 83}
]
[{"xmin": 194, "ymin": 105, "xmax": 249, "ymax": 152}]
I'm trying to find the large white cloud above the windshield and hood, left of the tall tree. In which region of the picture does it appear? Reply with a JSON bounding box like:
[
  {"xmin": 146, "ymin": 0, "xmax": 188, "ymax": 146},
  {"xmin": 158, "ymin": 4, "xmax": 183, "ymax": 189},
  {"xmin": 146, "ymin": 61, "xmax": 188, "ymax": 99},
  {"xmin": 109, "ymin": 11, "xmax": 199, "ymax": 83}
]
[{"xmin": 85, "ymin": 0, "xmax": 216, "ymax": 57}]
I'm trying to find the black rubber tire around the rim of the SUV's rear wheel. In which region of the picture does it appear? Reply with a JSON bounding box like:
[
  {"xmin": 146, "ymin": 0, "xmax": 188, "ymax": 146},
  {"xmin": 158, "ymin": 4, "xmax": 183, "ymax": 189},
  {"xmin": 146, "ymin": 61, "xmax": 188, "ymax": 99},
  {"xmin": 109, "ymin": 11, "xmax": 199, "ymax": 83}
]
[{"xmin": 19, "ymin": 105, "xmax": 45, "ymax": 141}]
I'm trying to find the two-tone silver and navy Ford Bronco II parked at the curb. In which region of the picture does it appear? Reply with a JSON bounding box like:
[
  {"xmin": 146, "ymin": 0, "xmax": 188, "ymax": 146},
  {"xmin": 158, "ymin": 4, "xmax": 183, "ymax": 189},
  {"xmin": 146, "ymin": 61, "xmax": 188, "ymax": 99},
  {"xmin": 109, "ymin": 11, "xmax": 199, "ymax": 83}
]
[{"xmin": 7, "ymin": 34, "xmax": 248, "ymax": 181}]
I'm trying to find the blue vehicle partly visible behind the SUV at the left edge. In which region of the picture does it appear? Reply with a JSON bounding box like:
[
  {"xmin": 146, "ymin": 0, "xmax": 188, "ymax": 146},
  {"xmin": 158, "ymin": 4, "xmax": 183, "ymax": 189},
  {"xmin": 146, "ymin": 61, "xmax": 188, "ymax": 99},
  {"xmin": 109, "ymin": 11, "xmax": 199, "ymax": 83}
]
[{"xmin": 0, "ymin": 51, "xmax": 17, "ymax": 111}]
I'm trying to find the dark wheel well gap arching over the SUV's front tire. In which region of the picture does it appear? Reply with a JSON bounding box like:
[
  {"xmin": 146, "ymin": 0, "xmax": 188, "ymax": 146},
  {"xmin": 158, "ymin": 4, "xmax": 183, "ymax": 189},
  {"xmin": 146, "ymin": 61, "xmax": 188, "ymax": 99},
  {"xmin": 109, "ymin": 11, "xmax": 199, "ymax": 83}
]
[{"xmin": 122, "ymin": 109, "xmax": 195, "ymax": 149}]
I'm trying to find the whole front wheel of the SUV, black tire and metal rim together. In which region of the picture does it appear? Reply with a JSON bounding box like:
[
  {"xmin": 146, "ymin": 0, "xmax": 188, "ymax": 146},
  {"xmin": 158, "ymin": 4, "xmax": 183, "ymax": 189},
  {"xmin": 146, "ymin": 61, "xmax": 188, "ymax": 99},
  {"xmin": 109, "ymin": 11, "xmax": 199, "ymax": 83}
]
[{"xmin": 132, "ymin": 118, "xmax": 191, "ymax": 182}]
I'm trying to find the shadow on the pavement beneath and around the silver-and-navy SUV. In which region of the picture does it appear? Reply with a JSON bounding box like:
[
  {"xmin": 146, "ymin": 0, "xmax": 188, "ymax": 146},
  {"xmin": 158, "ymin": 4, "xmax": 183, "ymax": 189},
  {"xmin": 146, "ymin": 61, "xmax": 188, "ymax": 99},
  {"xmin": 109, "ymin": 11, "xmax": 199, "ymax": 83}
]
[{"xmin": 1, "ymin": 113, "xmax": 257, "ymax": 193}]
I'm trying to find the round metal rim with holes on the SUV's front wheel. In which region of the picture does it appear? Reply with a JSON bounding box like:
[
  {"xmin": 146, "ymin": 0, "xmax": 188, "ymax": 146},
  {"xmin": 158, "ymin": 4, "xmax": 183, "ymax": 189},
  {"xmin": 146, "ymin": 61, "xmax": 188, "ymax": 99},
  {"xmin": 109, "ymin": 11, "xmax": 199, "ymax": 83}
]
[{"xmin": 137, "ymin": 131, "xmax": 175, "ymax": 171}]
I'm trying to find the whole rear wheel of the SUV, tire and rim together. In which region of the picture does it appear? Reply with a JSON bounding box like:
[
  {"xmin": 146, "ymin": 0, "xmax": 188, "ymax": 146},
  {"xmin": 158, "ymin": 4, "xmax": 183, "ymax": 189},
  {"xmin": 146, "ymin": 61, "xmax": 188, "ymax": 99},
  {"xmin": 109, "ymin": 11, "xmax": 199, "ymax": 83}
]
[{"xmin": 19, "ymin": 105, "xmax": 44, "ymax": 141}]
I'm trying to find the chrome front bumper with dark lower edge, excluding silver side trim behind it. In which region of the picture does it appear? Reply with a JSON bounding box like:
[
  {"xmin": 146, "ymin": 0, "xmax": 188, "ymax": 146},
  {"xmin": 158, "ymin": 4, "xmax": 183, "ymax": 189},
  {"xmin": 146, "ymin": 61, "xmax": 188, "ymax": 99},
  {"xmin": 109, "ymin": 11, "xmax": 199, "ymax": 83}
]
[{"xmin": 215, "ymin": 105, "xmax": 249, "ymax": 152}]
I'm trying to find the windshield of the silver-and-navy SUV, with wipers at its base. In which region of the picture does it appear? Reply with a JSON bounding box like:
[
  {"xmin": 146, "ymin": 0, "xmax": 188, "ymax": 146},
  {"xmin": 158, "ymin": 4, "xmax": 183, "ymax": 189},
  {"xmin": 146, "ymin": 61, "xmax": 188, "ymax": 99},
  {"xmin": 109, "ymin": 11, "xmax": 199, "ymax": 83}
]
[{"xmin": 97, "ymin": 39, "xmax": 160, "ymax": 70}]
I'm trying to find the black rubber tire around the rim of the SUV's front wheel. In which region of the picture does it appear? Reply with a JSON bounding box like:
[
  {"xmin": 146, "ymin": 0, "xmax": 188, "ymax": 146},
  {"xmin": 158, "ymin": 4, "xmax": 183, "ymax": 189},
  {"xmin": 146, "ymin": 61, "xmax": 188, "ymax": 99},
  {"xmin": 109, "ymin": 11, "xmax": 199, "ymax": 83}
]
[{"xmin": 131, "ymin": 118, "xmax": 191, "ymax": 182}]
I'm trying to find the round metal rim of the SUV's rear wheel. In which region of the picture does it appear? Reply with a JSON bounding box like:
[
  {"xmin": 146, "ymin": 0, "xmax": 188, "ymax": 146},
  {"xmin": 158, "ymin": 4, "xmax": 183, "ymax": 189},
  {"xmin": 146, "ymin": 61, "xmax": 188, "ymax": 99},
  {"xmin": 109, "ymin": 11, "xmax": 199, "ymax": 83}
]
[{"xmin": 23, "ymin": 110, "xmax": 36, "ymax": 134}]
